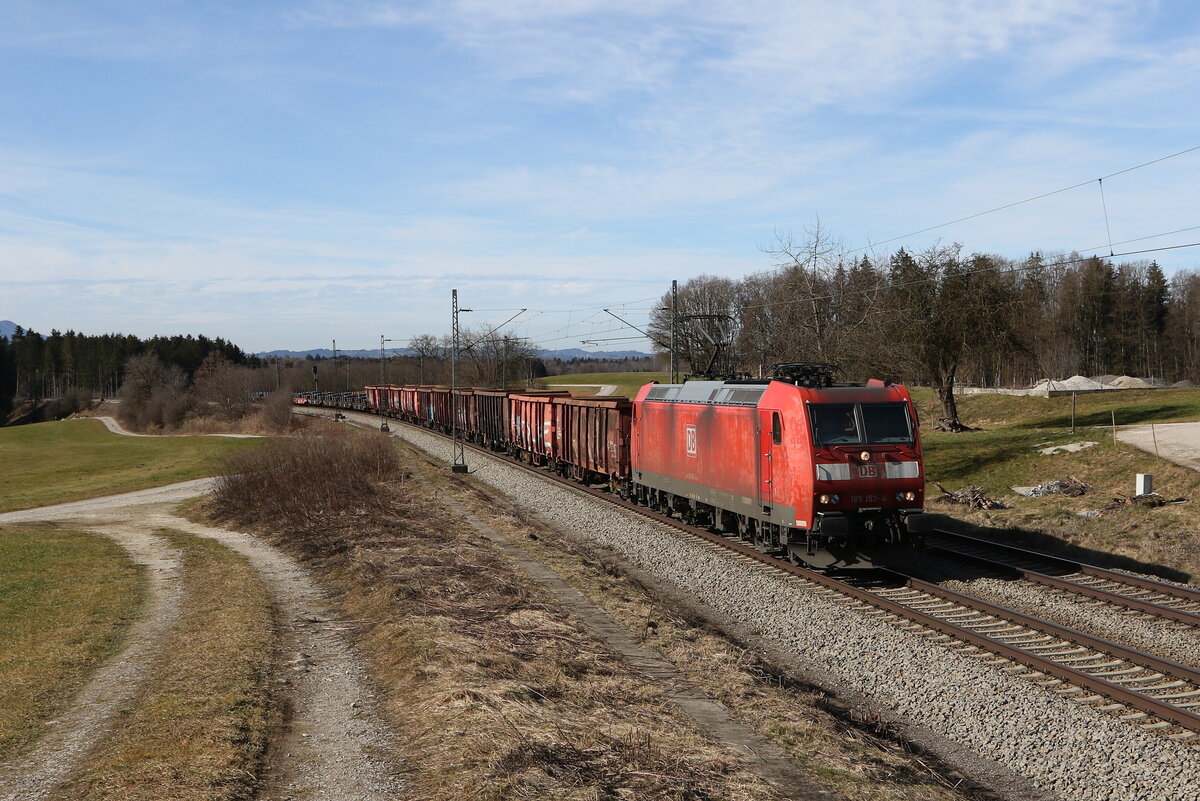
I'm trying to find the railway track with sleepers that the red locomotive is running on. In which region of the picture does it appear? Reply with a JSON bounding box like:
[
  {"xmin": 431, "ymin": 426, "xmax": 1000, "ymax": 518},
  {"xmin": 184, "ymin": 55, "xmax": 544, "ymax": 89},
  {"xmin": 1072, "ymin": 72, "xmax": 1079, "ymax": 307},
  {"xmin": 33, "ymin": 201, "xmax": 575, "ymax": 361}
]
[{"xmin": 304, "ymin": 410, "xmax": 1200, "ymax": 742}]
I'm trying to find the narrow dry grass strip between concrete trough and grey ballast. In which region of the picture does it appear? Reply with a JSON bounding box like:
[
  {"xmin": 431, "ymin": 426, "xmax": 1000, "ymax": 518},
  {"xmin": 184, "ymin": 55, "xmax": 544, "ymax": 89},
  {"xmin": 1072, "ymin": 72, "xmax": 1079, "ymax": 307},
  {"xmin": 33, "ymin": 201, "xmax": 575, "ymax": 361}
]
[{"xmin": 436, "ymin": 470, "xmax": 990, "ymax": 801}]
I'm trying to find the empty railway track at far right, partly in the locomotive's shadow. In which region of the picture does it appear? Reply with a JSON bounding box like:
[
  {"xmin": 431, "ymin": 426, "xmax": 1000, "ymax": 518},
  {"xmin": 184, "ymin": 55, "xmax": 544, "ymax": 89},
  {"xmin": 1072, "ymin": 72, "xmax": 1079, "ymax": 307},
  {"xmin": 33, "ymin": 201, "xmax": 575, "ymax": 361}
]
[{"xmin": 925, "ymin": 530, "xmax": 1200, "ymax": 626}]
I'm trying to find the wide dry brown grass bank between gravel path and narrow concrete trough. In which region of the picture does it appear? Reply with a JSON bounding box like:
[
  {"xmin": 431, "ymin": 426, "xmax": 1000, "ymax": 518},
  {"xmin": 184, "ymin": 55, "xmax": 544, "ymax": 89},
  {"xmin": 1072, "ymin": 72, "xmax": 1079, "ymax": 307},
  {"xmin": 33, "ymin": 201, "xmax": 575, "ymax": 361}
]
[{"xmin": 212, "ymin": 434, "xmax": 775, "ymax": 801}]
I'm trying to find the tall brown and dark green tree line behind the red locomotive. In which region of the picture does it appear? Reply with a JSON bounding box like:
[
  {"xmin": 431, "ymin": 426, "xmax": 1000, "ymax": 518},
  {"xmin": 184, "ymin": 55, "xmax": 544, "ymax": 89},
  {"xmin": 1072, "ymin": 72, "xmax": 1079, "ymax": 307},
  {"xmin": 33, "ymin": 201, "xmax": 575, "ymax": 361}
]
[{"xmin": 648, "ymin": 227, "xmax": 1200, "ymax": 428}]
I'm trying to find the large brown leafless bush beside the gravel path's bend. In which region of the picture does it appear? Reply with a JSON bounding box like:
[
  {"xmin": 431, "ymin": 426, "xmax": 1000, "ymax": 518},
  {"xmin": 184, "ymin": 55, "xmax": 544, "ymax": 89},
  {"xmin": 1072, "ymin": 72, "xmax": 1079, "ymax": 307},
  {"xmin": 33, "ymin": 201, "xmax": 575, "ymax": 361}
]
[{"xmin": 212, "ymin": 432, "xmax": 401, "ymax": 531}]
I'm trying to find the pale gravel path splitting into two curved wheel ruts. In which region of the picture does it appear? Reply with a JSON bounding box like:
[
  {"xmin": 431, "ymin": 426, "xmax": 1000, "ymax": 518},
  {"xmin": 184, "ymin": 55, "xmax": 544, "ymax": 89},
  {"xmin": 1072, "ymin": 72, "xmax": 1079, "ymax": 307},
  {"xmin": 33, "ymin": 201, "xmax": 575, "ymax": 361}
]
[{"xmin": 0, "ymin": 480, "xmax": 402, "ymax": 801}]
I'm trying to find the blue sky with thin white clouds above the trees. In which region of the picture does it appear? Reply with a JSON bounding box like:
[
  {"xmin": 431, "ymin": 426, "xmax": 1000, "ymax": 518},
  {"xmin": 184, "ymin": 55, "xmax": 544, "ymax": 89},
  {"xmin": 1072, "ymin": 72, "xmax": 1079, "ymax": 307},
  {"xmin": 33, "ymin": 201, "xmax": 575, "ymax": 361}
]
[{"xmin": 0, "ymin": 0, "xmax": 1200, "ymax": 350}]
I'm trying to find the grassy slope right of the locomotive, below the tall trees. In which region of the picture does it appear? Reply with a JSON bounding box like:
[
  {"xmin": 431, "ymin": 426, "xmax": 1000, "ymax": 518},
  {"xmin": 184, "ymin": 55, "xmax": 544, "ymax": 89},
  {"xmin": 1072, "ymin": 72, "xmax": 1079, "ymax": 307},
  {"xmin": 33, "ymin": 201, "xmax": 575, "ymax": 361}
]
[{"xmin": 913, "ymin": 389, "xmax": 1200, "ymax": 578}]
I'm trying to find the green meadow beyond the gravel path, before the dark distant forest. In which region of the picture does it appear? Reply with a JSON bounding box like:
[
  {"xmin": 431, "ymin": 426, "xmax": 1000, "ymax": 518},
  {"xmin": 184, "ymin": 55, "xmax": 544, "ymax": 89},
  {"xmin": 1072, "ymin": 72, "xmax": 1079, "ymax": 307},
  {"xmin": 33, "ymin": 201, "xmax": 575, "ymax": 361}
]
[{"xmin": 0, "ymin": 420, "xmax": 254, "ymax": 512}]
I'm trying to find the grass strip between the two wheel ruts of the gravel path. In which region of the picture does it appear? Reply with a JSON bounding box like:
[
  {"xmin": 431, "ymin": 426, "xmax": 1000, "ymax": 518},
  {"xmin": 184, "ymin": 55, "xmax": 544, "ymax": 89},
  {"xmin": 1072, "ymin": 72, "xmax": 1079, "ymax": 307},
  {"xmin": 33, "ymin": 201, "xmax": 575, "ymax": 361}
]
[{"xmin": 56, "ymin": 531, "xmax": 276, "ymax": 801}]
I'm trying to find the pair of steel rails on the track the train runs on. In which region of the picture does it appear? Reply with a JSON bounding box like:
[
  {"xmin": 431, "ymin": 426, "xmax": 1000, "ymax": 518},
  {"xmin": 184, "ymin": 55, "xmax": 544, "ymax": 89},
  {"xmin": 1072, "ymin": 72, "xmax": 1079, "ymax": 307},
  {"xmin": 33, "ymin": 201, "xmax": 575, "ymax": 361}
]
[{"xmin": 304, "ymin": 400, "xmax": 1200, "ymax": 731}]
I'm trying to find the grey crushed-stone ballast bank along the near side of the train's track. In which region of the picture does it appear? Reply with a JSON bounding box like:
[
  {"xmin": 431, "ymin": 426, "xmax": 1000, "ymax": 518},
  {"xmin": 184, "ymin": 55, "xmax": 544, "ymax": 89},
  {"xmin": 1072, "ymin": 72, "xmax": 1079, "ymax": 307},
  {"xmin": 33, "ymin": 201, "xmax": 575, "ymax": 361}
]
[{"xmin": 396, "ymin": 419, "xmax": 1200, "ymax": 801}]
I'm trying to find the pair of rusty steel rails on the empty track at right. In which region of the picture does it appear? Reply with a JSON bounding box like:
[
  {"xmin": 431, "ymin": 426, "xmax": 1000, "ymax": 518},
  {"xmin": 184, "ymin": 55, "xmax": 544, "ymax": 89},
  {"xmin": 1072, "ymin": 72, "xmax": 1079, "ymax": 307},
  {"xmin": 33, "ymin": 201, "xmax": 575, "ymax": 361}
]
[{"xmin": 925, "ymin": 530, "xmax": 1200, "ymax": 626}]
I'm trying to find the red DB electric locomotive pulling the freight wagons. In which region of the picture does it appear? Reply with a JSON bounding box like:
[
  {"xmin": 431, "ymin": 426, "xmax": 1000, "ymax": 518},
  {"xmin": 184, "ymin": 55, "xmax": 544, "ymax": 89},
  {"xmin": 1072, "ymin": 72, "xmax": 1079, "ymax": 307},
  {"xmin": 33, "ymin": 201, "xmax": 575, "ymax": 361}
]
[{"xmin": 629, "ymin": 365, "xmax": 924, "ymax": 567}]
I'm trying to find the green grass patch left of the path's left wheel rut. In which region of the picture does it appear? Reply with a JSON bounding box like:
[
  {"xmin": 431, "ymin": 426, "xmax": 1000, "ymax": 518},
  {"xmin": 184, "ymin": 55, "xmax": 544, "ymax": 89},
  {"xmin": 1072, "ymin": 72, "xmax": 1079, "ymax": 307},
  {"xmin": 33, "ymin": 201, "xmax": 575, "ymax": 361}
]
[{"xmin": 0, "ymin": 526, "xmax": 143, "ymax": 761}]
